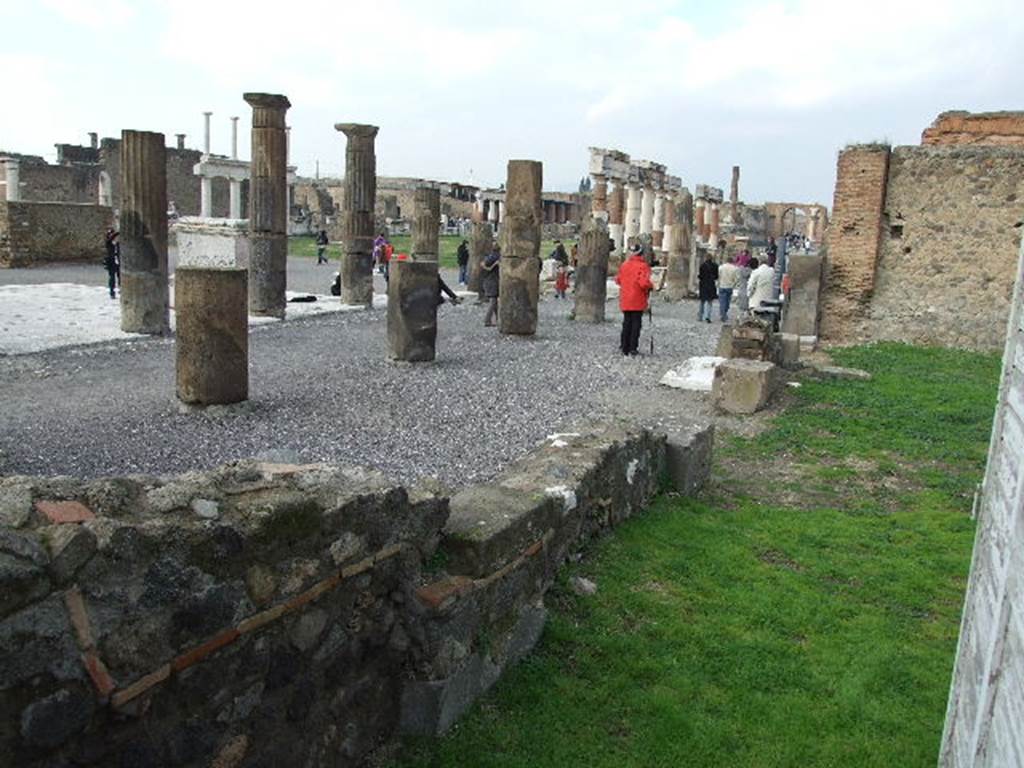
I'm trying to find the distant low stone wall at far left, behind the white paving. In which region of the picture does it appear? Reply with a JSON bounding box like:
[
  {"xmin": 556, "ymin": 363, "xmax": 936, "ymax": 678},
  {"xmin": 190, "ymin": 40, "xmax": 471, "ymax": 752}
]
[{"xmin": 0, "ymin": 202, "xmax": 114, "ymax": 267}]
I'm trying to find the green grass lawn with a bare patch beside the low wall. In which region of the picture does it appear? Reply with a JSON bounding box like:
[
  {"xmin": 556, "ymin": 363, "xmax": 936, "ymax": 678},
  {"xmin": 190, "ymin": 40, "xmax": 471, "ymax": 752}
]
[{"xmin": 399, "ymin": 344, "xmax": 999, "ymax": 768}]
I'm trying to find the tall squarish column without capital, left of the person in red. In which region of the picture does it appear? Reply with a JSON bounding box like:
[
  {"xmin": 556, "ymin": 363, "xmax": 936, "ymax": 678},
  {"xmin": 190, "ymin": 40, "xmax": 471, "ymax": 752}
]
[{"xmin": 498, "ymin": 160, "xmax": 544, "ymax": 336}]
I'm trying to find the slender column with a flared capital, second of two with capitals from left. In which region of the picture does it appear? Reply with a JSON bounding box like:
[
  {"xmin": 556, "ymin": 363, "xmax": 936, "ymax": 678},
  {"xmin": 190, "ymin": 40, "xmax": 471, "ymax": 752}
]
[{"xmin": 335, "ymin": 123, "xmax": 379, "ymax": 307}]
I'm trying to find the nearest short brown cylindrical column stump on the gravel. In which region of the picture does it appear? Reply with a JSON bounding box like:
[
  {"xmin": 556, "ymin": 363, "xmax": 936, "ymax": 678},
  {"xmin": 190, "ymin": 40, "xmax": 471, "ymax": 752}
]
[{"xmin": 174, "ymin": 266, "xmax": 249, "ymax": 406}]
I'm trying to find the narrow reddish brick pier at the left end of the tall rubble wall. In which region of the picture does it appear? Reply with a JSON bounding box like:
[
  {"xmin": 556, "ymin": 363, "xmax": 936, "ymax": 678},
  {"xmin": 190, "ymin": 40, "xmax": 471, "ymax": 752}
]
[{"xmin": 821, "ymin": 144, "xmax": 889, "ymax": 340}]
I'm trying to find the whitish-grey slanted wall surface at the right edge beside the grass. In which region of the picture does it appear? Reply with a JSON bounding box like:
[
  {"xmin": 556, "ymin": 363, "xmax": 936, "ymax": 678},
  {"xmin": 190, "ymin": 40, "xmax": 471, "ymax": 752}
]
[{"xmin": 939, "ymin": 237, "xmax": 1024, "ymax": 768}]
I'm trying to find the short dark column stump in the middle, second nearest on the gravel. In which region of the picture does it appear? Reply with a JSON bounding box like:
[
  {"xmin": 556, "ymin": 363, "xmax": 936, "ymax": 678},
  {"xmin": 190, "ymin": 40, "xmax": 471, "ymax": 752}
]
[{"xmin": 387, "ymin": 261, "xmax": 437, "ymax": 362}]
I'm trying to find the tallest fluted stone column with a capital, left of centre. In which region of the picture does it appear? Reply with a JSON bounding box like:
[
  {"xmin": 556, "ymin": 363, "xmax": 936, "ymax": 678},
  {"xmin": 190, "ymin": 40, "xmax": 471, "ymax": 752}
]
[{"xmin": 243, "ymin": 93, "xmax": 292, "ymax": 317}]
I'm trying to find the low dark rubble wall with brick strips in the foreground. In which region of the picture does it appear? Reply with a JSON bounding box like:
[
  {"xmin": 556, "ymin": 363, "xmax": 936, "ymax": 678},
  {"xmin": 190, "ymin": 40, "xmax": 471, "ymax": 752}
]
[{"xmin": 0, "ymin": 425, "xmax": 712, "ymax": 766}]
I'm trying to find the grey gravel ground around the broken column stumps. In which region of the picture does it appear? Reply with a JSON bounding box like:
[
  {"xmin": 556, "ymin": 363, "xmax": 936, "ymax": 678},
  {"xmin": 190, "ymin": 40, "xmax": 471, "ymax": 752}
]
[{"xmin": 0, "ymin": 263, "xmax": 719, "ymax": 486}]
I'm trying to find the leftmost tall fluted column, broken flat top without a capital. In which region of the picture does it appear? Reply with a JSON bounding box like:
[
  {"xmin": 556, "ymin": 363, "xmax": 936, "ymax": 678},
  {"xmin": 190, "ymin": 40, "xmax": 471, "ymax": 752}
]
[{"xmin": 121, "ymin": 131, "xmax": 169, "ymax": 335}]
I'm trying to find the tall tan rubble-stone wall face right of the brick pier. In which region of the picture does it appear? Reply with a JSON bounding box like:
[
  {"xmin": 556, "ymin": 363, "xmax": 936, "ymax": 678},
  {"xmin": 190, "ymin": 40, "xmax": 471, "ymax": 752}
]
[{"xmin": 864, "ymin": 146, "xmax": 1024, "ymax": 349}]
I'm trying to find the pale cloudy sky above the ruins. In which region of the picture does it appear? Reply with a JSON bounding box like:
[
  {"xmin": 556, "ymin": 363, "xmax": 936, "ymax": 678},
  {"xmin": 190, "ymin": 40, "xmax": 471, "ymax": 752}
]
[{"xmin": 0, "ymin": 0, "xmax": 1024, "ymax": 207}]
